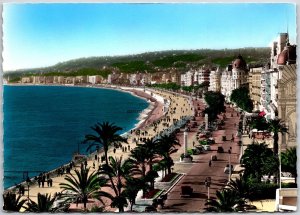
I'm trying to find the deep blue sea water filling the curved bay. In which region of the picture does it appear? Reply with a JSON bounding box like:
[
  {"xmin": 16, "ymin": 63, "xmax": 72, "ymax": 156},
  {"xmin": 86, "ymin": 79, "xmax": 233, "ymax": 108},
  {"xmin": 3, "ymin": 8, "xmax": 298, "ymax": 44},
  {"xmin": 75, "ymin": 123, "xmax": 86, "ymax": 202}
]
[{"xmin": 3, "ymin": 86, "xmax": 149, "ymax": 188}]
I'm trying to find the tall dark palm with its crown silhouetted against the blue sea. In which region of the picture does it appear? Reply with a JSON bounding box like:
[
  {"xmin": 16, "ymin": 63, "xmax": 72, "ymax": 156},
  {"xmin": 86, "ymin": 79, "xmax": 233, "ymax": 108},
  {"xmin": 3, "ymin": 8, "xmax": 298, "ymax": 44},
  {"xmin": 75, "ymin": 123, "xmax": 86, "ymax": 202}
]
[{"xmin": 83, "ymin": 122, "xmax": 127, "ymax": 164}]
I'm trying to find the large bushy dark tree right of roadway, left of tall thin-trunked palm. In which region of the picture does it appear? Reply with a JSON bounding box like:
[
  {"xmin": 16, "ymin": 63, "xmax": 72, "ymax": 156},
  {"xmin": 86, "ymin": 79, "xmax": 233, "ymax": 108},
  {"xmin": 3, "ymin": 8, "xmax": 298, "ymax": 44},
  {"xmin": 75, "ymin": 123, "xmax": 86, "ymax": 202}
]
[{"xmin": 241, "ymin": 143, "xmax": 278, "ymax": 181}]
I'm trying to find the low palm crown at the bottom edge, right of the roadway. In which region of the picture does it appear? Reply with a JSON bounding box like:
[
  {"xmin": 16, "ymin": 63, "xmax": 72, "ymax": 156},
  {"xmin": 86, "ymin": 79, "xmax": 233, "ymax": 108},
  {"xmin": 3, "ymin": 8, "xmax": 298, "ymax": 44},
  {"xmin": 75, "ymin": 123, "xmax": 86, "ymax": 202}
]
[{"xmin": 205, "ymin": 190, "xmax": 245, "ymax": 212}]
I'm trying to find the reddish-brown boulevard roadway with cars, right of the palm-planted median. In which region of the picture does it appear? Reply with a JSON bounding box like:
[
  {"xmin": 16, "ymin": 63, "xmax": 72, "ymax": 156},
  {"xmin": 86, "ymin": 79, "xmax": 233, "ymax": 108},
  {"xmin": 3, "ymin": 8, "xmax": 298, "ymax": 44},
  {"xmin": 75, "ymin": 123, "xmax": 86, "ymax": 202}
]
[{"xmin": 161, "ymin": 101, "xmax": 240, "ymax": 212}]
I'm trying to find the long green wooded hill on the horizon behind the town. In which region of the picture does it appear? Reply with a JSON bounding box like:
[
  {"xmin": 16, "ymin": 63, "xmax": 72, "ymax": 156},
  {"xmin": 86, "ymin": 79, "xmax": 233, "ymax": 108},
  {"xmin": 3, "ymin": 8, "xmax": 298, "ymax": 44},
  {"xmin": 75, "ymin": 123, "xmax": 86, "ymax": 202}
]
[{"xmin": 4, "ymin": 47, "xmax": 270, "ymax": 76}]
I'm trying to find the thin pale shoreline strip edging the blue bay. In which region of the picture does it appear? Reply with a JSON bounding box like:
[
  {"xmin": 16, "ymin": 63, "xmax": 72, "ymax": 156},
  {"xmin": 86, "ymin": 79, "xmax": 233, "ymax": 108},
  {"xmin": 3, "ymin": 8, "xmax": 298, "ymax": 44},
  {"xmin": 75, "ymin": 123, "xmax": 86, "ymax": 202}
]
[{"xmin": 3, "ymin": 84, "xmax": 163, "ymax": 192}]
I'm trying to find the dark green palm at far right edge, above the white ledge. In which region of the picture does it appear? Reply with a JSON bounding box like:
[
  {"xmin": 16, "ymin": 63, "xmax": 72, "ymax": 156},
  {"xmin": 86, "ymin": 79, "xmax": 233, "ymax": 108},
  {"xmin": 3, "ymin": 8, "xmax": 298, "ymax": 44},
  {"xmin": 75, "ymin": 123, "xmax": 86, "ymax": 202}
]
[{"xmin": 281, "ymin": 147, "xmax": 297, "ymax": 183}]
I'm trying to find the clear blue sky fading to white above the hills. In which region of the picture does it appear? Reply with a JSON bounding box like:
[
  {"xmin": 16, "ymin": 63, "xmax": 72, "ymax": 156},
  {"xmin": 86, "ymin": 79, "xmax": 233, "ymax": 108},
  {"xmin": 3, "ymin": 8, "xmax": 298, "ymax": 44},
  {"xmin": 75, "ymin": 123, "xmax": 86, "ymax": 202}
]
[{"xmin": 3, "ymin": 3, "xmax": 296, "ymax": 71}]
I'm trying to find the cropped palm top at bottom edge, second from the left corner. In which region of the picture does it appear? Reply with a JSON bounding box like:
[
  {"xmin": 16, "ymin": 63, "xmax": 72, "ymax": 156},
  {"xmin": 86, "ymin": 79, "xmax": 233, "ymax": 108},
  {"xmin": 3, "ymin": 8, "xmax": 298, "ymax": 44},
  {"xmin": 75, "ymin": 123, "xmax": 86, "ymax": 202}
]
[{"xmin": 26, "ymin": 193, "xmax": 56, "ymax": 213}]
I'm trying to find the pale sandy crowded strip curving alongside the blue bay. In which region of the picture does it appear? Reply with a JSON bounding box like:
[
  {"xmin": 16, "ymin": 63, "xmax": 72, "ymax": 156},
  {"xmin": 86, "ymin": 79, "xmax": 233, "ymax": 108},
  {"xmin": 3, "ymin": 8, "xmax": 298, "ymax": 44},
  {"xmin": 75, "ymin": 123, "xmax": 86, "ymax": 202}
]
[{"xmin": 6, "ymin": 85, "xmax": 194, "ymax": 211}]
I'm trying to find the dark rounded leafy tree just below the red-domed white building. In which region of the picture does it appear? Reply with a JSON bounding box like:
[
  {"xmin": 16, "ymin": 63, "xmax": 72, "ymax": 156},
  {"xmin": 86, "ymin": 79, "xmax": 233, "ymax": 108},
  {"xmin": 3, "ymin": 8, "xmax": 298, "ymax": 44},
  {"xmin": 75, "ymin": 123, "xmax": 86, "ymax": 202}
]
[{"xmin": 230, "ymin": 86, "xmax": 253, "ymax": 113}]
